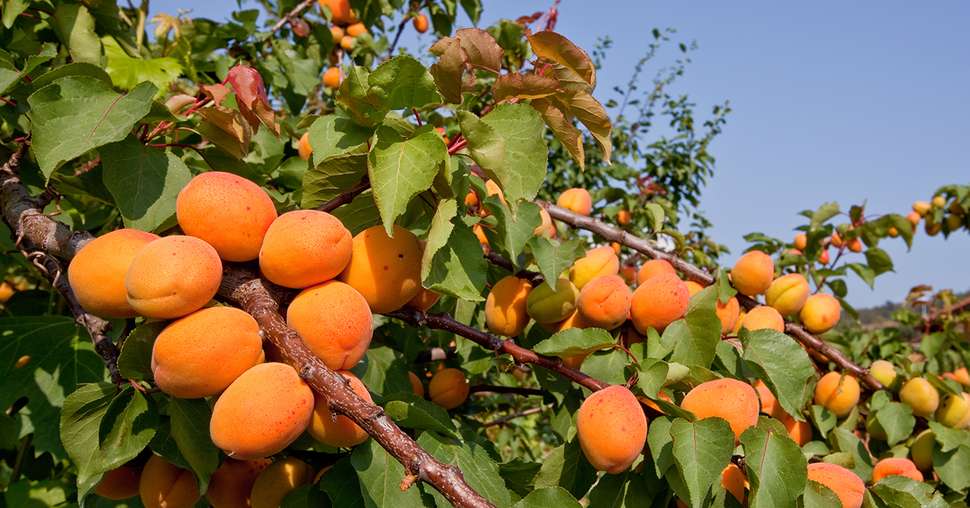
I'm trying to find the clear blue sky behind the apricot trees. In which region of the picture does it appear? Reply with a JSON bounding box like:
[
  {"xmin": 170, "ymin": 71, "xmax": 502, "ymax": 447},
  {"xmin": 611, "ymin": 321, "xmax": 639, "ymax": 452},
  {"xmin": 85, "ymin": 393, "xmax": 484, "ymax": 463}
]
[{"xmin": 152, "ymin": 0, "xmax": 970, "ymax": 306}]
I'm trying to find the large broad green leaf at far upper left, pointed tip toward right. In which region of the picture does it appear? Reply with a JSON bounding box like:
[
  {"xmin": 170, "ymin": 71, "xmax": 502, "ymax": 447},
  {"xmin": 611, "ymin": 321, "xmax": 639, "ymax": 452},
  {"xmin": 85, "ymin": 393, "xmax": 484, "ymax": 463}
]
[{"xmin": 27, "ymin": 76, "xmax": 156, "ymax": 178}]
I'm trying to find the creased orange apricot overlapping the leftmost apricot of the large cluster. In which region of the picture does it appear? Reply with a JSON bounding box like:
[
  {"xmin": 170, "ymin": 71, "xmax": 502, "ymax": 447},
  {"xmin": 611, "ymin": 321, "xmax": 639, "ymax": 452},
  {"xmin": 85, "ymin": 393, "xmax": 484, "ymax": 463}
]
[{"xmin": 125, "ymin": 235, "xmax": 222, "ymax": 319}]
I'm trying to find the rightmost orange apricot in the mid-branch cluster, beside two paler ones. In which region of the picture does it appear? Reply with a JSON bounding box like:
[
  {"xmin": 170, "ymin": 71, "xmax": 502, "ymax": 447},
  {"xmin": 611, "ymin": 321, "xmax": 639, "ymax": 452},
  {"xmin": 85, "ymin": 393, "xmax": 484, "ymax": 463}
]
[{"xmin": 630, "ymin": 273, "xmax": 690, "ymax": 335}]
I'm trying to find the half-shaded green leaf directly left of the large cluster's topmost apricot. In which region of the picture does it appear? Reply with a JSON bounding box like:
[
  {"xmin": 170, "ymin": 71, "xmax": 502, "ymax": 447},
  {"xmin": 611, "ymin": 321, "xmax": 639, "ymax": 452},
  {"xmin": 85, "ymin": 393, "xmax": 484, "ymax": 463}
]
[{"xmin": 100, "ymin": 136, "xmax": 192, "ymax": 231}]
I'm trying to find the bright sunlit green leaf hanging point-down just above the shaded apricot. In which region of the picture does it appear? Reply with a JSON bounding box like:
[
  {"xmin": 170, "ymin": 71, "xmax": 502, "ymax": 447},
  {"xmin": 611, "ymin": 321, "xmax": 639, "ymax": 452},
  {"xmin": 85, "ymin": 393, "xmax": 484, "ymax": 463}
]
[{"xmin": 367, "ymin": 125, "xmax": 448, "ymax": 234}]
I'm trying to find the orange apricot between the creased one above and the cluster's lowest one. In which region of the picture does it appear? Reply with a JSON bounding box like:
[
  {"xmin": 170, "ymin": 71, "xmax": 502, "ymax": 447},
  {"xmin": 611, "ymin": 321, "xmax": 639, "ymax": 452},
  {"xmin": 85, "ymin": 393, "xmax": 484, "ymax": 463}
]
[{"xmin": 151, "ymin": 307, "xmax": 263, "ymax": 399}]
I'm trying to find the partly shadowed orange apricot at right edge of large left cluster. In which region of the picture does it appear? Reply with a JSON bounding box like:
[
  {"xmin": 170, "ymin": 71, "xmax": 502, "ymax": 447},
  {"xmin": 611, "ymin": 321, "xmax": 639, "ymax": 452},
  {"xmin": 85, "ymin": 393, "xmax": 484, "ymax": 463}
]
[{"xmin": 340, "ymin": 225, "xmax": 421, "ymax": 313}]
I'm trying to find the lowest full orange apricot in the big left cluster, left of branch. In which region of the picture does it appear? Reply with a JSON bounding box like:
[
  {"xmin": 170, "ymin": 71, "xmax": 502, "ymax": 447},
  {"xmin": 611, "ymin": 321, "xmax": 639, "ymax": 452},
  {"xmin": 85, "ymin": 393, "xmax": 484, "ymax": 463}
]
[{"xmin": 209, "ymin": 362, "xmax": 313, "ymax": 460}]
